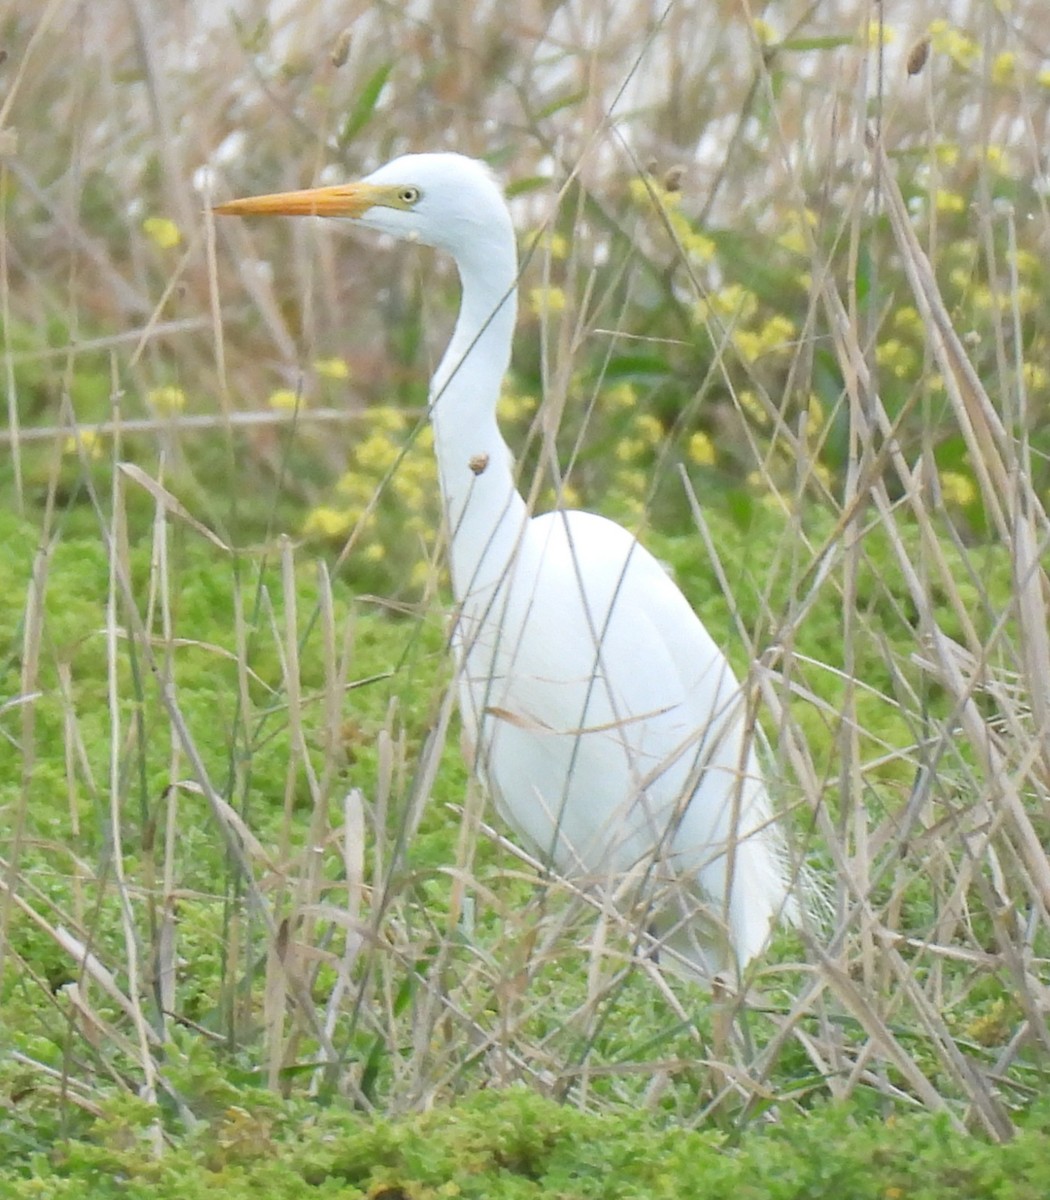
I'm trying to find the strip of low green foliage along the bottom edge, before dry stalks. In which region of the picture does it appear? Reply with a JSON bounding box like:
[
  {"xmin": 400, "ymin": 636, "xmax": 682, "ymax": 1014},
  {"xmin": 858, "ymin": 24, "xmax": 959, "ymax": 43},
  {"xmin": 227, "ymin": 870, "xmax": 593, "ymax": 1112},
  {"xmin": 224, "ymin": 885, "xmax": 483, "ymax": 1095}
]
[{"xmin": 6, "ymin": 1091, "xmax": 1050, "ymax": 1200}]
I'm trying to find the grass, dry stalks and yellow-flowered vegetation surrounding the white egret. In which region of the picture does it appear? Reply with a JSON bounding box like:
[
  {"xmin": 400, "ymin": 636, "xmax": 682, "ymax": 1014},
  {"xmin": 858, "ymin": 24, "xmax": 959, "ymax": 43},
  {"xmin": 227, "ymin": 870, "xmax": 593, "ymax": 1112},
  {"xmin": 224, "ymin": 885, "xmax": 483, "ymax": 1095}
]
[{"xmin": 0, "ymin": 0, "xmax": 1050, "ymax": 1200}]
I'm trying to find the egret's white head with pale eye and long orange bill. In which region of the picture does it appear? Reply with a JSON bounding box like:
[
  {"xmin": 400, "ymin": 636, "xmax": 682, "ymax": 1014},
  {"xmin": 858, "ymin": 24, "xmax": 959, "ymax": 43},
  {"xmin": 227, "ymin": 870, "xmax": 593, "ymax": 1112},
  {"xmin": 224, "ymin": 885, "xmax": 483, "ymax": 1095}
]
[{"xmin": 215, "ymin": 154, "xmax": 512, "ymax": 258}]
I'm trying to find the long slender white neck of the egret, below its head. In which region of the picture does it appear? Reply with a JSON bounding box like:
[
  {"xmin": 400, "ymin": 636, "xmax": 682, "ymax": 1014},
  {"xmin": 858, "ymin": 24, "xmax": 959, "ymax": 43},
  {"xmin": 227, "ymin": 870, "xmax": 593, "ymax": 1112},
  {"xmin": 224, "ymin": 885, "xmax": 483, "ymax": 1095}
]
[{"xmin": 431, "ymin": 233, "xmax": 527, "ymax": 604}]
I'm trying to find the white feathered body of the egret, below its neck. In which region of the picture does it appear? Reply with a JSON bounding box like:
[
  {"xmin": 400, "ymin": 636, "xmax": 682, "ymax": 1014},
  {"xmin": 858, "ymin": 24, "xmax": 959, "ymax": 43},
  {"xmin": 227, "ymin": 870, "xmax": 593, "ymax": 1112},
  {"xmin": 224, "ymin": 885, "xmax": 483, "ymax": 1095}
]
[{"xmin": 458, "ymin": 512, "xmax": 785, "ymax": 962}]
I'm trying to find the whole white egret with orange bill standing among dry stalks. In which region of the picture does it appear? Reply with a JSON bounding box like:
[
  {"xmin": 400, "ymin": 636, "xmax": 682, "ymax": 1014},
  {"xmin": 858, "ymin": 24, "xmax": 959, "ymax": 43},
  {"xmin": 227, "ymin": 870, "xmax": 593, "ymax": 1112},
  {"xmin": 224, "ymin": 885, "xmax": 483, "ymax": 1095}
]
[{"xmin": 215, "ymin": 154, "xmax": 798, "ymax": 974}]
